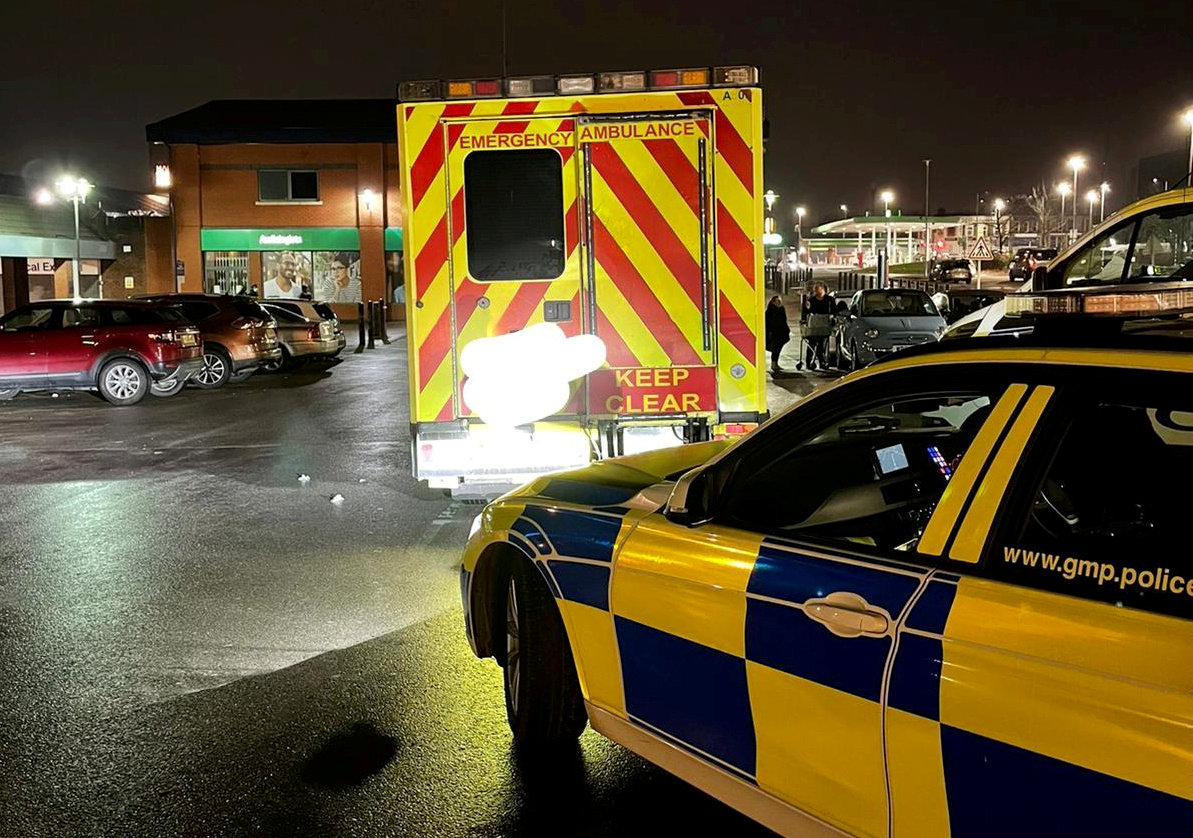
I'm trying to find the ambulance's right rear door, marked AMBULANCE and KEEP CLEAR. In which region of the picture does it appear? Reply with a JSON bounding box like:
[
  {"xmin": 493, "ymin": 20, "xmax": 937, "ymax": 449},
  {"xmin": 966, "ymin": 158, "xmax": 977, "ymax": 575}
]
[{"xmin": 576, "ymin": 112, "xmax": 717, "ymax": 420}]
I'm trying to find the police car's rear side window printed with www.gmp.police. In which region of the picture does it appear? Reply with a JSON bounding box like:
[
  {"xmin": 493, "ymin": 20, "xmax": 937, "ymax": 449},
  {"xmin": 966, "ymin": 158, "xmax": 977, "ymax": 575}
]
[{"xmin": 987, "ymin": 400, "xmax": 1193, "ymax": 618}]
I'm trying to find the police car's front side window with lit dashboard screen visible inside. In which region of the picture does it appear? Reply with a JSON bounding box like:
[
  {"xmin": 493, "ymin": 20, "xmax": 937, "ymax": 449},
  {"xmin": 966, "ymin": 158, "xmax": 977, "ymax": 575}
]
[{"xmin": 716, "ymin": 390, "xmax": 997, "ymax": 552}]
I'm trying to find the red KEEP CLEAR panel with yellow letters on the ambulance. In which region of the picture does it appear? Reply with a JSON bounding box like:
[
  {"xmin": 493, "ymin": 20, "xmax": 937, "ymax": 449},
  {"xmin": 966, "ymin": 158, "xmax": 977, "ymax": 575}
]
[{"xmin": 588, "ymin": 366, "xmax": 717, "ymax": 415}]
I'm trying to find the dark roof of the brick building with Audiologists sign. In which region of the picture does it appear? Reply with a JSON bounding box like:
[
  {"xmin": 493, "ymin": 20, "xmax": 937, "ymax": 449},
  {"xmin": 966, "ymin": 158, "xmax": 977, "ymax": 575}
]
[{"xmin": 146, "ymin": 99, "xmax": 397, "ymax": 146}]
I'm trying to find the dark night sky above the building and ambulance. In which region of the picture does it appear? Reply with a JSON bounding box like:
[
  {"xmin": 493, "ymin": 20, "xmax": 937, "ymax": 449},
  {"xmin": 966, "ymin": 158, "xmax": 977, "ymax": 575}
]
[{"xmin": 0, "ymin": 0, "xmax": 1193, "ymax": 220}]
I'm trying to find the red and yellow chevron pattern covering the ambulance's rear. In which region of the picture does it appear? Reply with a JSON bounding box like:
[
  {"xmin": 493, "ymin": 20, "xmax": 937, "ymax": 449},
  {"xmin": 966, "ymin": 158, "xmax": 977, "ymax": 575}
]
[{"xmin": 397, "ymin": 88, "xmax": 766, "ymax": 423}]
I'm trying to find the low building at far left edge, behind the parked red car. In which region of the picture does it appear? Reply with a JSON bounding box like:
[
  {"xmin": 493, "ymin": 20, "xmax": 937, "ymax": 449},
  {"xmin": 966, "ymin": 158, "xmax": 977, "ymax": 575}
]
[{"xmin": 0, "ymin": 174, "xmax": 173, "ymax": 313}]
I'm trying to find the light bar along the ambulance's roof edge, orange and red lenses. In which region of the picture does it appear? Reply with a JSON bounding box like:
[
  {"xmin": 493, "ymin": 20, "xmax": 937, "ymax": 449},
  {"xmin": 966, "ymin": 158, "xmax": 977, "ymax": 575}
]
[{"xmin": 397, "ymin": 66, "xmax": 758, "ymax": 101}]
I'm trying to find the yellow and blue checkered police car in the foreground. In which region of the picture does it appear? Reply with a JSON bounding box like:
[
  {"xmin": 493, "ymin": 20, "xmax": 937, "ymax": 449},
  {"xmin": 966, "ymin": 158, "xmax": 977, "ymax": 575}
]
[{"xmin": 462, "ymin": 282, "xmax": 1193, "ymax": 838}]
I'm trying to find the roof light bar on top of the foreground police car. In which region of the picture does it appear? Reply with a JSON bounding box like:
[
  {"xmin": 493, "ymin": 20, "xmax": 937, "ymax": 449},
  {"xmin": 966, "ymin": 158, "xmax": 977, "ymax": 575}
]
[{"xmin": 1005, "ymin": 282, "xmax": 1193, "ymax": 318}]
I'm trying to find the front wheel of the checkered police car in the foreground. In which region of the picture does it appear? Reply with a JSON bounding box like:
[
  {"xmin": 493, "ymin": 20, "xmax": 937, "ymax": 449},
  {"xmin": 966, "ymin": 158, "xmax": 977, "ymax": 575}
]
[{"xmin": 503, "ymin": 561, "xmax": 587, "ymax": 747}]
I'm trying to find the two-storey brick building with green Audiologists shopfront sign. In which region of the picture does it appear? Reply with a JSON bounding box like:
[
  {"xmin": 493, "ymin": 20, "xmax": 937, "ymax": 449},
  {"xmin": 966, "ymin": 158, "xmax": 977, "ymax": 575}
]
[{"xmin": 146, "ymin": 99, "xmax": 404, "ymax": 318}]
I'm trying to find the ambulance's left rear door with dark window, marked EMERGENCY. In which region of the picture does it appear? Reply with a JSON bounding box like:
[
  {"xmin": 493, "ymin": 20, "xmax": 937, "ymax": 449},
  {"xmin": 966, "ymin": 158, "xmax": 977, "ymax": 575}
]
[{"xmin": 444, "ymin": 112, "xmax": 583, "ymax": 424}]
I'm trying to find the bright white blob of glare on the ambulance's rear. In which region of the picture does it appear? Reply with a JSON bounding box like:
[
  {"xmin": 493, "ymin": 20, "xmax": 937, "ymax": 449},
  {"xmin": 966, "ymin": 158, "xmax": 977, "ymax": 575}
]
[{"xmin": 459, "ymin": 324, "xmax": 605, "ymax": 427}]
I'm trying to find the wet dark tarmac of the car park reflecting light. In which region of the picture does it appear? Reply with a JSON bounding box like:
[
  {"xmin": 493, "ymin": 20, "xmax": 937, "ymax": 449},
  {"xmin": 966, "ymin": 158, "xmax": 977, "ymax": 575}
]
[{"xmin": 0, "ymin": 343, "xmax": 769, "ymax": 837}]
